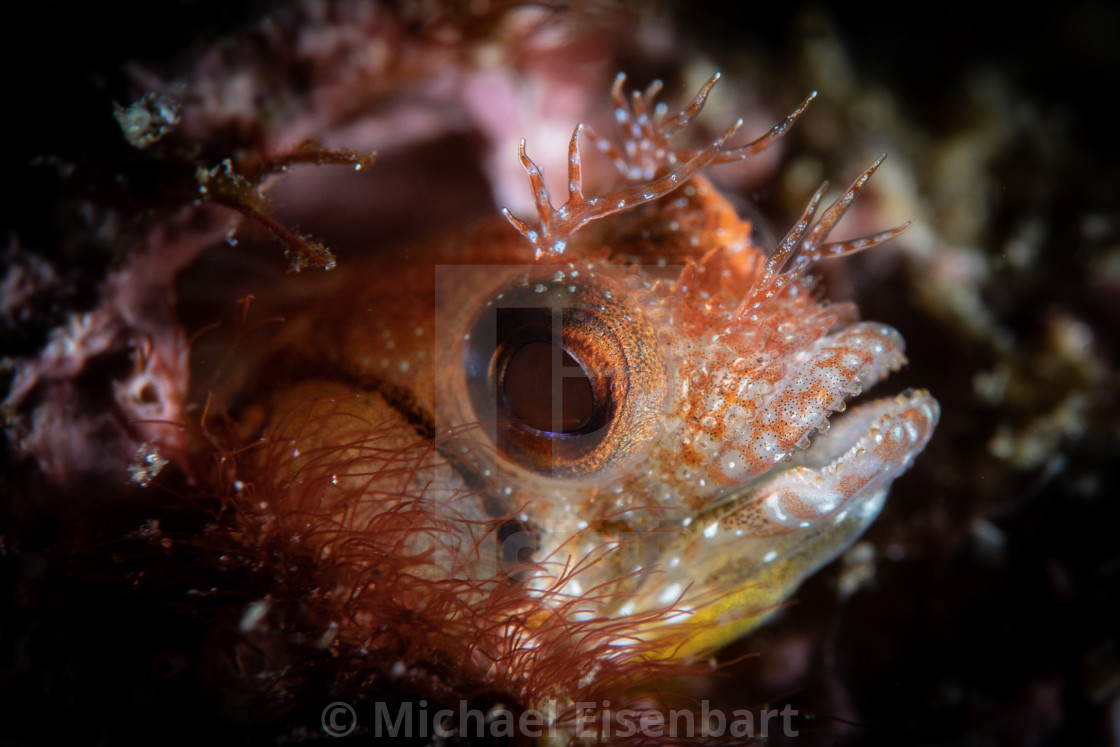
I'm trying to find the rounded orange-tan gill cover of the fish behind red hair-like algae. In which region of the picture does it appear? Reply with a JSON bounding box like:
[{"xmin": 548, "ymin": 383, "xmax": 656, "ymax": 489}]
[{"xmin": 253, "ymin": 381, "xmax": 497, "ymax": 582}]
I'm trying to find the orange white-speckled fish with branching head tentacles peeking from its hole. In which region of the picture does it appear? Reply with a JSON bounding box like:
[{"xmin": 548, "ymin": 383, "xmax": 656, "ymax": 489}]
[{"xmin": 222, "ymin": 75, "xmax": 939, "ymax": 725}]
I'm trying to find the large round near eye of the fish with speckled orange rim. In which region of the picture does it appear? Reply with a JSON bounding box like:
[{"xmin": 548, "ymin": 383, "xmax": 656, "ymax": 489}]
[{"xmin": 464, "ymin": 273, "xmax": 666, "ymax": 478}]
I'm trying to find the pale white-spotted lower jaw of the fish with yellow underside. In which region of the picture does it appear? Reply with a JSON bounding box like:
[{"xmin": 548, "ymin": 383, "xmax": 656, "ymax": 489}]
[{"xmin": 620, "ymin": 390, "xmax": 940, "ymax": 655}]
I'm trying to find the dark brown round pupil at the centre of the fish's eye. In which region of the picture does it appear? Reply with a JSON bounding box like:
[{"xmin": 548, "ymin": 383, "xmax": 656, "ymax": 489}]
[{"xmin": 502, "ymin": 342, "xmax": 595, "ymax": 433}]
